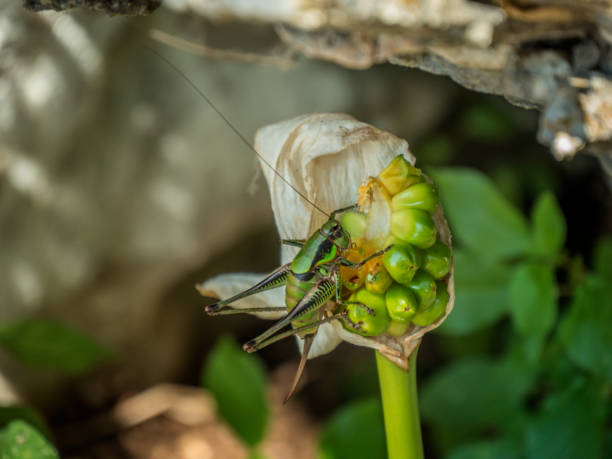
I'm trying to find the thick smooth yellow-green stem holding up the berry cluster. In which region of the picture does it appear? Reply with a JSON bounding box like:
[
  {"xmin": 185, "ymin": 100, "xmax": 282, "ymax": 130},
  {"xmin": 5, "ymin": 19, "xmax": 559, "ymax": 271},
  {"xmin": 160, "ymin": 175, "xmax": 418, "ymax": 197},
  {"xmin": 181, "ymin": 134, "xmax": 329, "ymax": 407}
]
[{"xmin": 376, "ymin": 349, "xmax": 423, "ymax": 459}]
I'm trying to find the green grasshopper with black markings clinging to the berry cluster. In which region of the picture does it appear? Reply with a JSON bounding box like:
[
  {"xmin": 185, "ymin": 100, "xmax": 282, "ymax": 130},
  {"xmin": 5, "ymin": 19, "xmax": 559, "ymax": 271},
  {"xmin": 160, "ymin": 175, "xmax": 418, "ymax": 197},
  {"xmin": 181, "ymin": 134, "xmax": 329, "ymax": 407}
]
[{"xmin": 205, "ymin": 205, "xmax": 390, "ymax": 401}]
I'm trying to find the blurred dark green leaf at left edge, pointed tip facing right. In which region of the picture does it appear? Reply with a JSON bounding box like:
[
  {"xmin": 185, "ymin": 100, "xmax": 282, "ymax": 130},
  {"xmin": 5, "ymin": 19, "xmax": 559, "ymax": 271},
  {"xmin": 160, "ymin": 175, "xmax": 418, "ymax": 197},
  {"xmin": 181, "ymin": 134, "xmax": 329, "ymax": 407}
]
[{"xmin": 0, "ymin": 319, "xmax": 111, "ymax": 373}]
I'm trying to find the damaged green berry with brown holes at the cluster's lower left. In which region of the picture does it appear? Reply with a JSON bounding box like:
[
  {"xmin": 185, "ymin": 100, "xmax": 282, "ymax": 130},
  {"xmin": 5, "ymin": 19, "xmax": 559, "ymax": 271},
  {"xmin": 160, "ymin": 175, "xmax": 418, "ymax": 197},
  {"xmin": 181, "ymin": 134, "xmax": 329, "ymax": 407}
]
[{"xmin": 345, "ymin": 289, "xmax": 391, "ymax": 336}]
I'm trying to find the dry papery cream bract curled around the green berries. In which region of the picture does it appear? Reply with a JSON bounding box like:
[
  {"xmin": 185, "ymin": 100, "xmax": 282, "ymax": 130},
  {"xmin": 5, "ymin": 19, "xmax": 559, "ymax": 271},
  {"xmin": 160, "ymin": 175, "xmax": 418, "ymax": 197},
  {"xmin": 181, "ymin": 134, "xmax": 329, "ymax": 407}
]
[{"xmin": 198, "ymin": 113, "xmax": 455, "ymax": 370}]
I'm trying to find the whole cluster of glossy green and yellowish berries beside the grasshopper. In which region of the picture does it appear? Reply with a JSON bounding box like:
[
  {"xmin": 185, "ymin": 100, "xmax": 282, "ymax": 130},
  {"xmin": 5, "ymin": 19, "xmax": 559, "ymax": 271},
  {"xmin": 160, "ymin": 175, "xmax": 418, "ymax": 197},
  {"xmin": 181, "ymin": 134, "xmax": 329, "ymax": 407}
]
[{"xmin": 343, "ymin": 156, "xmax": 451, "ymax": 336}]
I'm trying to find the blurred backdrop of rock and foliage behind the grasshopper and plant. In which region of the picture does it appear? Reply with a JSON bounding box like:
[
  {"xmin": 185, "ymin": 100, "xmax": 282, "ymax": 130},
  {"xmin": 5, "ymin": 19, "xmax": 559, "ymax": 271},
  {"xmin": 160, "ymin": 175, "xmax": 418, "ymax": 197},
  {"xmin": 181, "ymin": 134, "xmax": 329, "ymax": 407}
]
[{"xmin": 0, "ymin": 0, "xmax": 612, "ymax": 459}]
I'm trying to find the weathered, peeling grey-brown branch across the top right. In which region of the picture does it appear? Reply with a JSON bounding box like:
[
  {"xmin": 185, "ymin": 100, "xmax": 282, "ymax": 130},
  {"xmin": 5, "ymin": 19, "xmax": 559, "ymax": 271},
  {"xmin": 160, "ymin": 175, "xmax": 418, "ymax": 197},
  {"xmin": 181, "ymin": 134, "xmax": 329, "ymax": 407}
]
[{"xmin": 160, "ymin": 0, "xmax": 612, "ymax": 165}]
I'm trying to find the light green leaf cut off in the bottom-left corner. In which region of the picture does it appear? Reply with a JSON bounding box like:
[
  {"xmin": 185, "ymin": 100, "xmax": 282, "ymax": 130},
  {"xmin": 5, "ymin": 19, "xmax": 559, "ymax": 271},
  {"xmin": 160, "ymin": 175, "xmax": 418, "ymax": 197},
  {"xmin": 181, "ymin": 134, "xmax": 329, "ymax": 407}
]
[{"xmin": 0, "ymin": 420, "xmax": 59, "ymax": 459}]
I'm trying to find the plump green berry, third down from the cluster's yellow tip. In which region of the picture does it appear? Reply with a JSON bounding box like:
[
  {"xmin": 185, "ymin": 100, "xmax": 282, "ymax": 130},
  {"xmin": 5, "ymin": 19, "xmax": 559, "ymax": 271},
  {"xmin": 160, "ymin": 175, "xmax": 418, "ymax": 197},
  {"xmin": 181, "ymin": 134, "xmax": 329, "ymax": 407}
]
[{"xmin": 391, "ymin": 209, "xmax": 438, "ymax": 249}]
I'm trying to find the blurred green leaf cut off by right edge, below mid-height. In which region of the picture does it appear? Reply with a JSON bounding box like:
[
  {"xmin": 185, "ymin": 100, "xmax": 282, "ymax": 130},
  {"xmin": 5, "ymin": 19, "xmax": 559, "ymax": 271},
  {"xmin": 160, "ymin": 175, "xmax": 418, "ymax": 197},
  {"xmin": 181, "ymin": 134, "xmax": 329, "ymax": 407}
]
[{"xmin": 559, "ymin": 275, "xmax": 612, "ymax": 381}]
